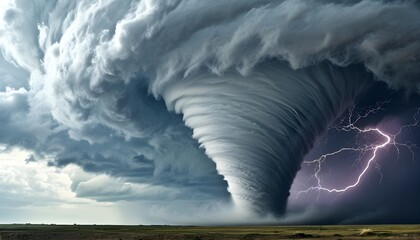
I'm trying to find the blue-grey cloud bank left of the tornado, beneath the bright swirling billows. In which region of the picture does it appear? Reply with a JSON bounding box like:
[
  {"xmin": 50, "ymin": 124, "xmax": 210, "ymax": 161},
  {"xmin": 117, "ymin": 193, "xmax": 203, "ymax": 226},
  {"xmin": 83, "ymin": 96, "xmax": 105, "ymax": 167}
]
[{"xmin": 0, "ymin": 59, "xmax": 228, "ymax": 205}]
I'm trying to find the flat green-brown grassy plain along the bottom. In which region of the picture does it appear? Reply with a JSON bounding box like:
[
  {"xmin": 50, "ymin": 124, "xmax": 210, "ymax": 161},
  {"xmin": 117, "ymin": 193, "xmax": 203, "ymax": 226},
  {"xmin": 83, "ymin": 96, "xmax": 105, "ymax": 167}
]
[{"xmin": 0, "ymin": 224, "xmax": 420, "ymax": 240}]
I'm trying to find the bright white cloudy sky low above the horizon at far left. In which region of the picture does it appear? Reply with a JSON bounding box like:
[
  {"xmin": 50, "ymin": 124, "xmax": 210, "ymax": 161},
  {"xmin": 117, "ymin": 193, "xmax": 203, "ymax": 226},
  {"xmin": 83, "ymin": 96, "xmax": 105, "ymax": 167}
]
[{"xmin": 0, "ymin": 146, "xmax": 128, "ymax": 223}]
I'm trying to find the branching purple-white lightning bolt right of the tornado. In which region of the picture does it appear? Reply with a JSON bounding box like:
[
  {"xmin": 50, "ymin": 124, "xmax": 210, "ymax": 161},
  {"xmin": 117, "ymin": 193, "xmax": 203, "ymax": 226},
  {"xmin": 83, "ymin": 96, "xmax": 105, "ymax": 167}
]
[{"xmin": 298, "ymin": 102, "xmax": 420, "ymax": 196}]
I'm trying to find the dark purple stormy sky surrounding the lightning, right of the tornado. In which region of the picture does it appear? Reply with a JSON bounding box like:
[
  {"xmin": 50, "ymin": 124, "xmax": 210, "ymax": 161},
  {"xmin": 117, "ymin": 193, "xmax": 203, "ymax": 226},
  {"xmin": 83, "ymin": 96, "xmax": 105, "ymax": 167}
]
[{"xmin": 289, "ymin": 93, "xmax": 420, "ymax": 224}]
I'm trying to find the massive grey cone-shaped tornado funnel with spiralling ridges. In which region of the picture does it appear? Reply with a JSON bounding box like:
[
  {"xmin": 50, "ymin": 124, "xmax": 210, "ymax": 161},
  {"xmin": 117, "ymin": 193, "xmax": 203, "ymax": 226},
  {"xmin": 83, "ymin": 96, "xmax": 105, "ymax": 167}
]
[{"xmin": 163, "ymin": 62, "xmax": 369, "ymax": 216}]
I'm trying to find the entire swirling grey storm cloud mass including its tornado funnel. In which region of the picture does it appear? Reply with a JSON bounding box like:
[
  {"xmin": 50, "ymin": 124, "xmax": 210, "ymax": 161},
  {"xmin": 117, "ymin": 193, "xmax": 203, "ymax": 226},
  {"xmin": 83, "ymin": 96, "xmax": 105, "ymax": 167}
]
[{"xmin": 0, "ymin": 0, "xmax": 420, "ymax": 223}]
